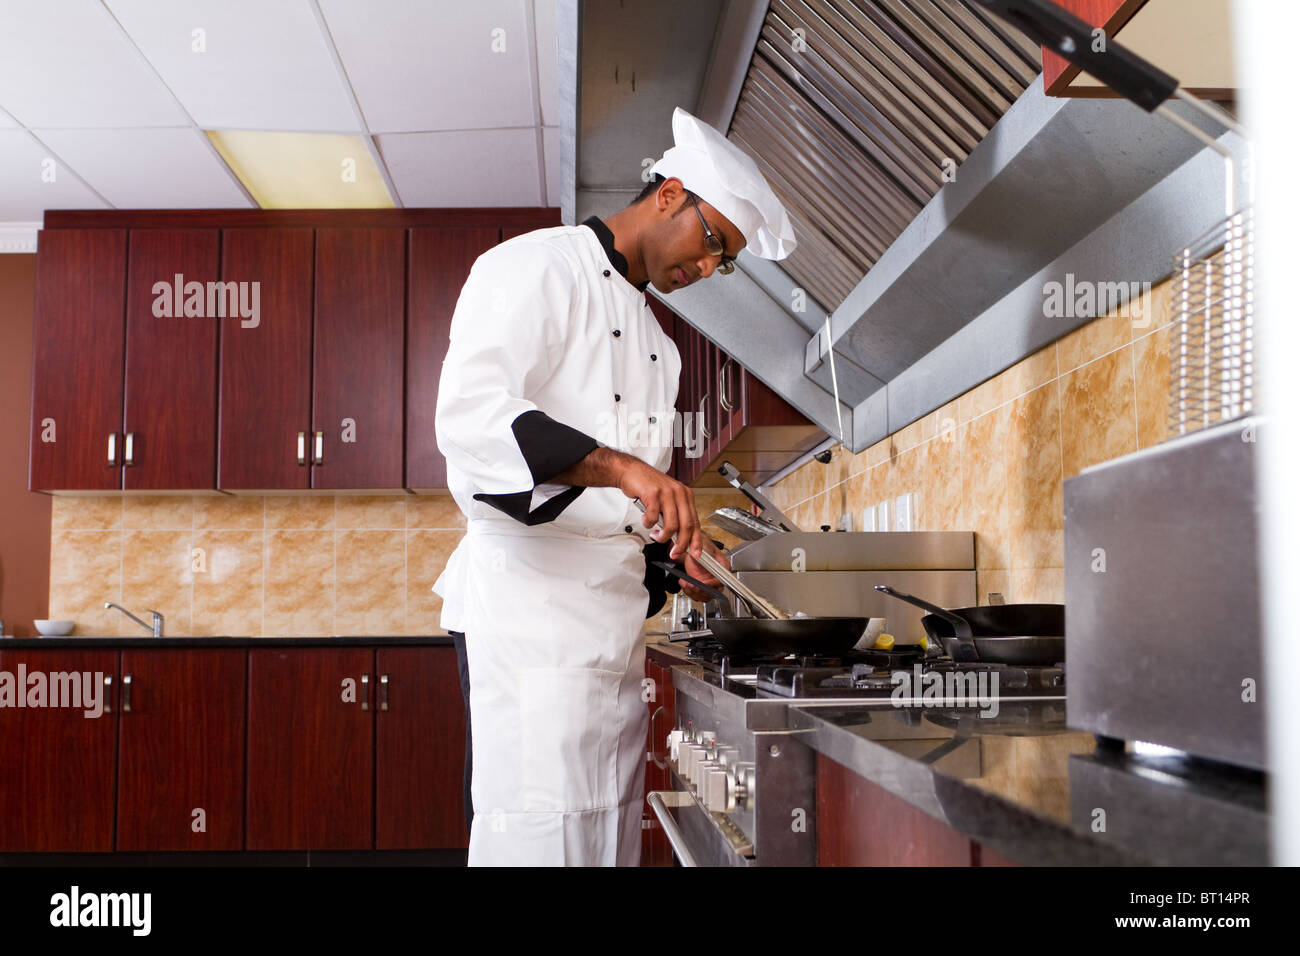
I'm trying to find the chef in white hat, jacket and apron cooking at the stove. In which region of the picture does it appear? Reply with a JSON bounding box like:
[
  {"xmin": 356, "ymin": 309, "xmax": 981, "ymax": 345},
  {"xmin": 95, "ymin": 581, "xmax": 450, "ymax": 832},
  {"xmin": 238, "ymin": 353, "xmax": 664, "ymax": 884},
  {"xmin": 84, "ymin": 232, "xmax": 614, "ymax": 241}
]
[{"xmin": 434, "ymin": 108, "xmax": 794, "ymax": 866}]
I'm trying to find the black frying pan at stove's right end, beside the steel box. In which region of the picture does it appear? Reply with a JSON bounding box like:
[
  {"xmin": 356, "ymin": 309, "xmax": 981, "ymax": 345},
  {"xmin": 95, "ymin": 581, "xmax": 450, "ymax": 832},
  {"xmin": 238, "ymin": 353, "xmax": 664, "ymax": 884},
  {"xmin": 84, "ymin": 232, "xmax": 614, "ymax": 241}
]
[{"xmin": 876, "ymin": 584, "xmax": 1065, "ymax": 666}]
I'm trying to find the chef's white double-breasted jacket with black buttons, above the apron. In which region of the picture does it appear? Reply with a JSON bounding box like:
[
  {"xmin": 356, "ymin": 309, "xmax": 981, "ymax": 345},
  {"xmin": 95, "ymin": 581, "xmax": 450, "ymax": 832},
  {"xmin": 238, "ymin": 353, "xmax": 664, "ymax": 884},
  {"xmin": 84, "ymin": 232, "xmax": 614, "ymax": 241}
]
[{"xmin": 433, "ymin": 224, "xmax": 681, "ymax": 631}]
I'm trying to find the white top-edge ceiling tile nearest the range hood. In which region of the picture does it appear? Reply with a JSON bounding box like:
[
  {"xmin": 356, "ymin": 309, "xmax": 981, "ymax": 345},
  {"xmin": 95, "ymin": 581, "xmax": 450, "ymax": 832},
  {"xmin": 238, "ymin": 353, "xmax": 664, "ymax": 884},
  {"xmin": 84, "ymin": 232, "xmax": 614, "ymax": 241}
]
[{"xmin": 317, "ymin": 0, "xmax": 537, "ymax": 133}]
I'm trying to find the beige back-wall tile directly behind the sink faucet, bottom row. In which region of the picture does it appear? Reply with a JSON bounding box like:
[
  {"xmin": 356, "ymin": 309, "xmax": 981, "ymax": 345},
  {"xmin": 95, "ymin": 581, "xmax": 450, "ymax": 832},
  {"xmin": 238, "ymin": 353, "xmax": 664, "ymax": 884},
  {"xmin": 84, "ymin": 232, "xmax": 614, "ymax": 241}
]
[{"xmin": 118, "ymin": 531, "xmax": 194, "ymax": 637}]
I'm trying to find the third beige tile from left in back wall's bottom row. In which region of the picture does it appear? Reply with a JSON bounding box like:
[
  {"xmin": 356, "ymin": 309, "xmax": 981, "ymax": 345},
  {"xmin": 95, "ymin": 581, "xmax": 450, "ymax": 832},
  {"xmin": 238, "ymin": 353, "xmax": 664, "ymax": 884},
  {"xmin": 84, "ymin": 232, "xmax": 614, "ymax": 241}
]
[{"xmin": 192, "ymin": 529, "xmax": 264, "ymax": 637}]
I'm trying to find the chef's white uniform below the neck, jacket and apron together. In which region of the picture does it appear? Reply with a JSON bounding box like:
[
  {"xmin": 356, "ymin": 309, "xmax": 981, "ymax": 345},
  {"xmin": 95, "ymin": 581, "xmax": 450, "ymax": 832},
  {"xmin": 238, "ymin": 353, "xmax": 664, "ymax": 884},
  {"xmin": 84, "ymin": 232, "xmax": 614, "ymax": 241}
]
[{"xmin": 434, "ymin": 226, "xmax": 681, "ymax": 866}]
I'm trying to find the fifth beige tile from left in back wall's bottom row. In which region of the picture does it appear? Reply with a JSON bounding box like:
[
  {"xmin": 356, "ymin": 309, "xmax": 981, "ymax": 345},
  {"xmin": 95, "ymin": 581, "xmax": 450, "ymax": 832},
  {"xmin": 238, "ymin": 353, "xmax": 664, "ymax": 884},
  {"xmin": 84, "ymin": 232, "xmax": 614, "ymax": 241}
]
[{"xmin": 334, "ymin": 529, "xmax": 407, "ymax": 635}]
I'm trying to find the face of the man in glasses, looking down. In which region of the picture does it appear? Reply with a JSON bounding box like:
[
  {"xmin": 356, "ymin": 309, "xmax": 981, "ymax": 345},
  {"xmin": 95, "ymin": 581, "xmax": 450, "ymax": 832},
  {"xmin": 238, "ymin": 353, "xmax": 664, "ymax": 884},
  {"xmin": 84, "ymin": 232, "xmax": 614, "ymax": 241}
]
[{"xmin": 642, "ymin": 178, "xmax": 745, "ymax": 293}]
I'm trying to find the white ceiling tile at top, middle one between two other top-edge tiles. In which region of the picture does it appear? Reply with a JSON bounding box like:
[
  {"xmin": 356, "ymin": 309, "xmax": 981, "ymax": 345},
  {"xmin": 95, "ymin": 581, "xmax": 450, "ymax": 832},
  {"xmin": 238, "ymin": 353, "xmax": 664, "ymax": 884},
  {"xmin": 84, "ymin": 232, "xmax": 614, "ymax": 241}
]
[{"xmin": 107, "ymin": 0, "xmax": 360, "ymax": 133}]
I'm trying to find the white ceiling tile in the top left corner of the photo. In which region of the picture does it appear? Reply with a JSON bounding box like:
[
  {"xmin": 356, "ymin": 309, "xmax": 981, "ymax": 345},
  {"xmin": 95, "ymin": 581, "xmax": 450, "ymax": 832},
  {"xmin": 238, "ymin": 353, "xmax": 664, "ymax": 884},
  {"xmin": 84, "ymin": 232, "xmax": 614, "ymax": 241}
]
[{"xmin": 0, "ymin": 0, "xmax": 189, "ymax": 129}]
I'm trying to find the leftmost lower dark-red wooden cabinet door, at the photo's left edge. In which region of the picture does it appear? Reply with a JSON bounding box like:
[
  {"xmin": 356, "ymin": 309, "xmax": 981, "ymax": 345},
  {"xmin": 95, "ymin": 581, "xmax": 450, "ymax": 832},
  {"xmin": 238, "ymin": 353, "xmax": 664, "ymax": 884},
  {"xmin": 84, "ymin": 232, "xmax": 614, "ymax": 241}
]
[{"xmin": 0, "ymin": 650, "xmax": 118, "ymax": 853}]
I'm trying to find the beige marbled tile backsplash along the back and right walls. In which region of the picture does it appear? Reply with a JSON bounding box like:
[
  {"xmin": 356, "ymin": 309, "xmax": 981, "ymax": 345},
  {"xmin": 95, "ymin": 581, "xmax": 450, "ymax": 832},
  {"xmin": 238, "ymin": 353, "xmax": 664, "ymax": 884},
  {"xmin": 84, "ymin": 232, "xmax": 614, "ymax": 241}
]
[{"xmin": 49, "ymin": 284, "xmax": 1171, "ymax": 636}]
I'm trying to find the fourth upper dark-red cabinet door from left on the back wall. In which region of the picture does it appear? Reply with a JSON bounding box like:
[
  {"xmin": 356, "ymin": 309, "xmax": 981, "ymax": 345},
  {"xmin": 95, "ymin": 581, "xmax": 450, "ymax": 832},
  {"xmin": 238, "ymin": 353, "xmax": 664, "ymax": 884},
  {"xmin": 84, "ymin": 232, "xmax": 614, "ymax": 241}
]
[{"xmin": 311, "ymin": 229, "xmax": 406, "ymax": 490}]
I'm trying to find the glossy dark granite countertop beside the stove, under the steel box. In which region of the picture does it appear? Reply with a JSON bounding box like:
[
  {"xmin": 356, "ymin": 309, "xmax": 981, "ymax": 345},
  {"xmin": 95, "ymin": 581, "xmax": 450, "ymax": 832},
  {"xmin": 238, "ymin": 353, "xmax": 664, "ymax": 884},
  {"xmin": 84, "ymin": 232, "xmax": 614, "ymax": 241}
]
[{"xmin": 650, "ymin": 643, "xmax": 1269, "ymax": 865}]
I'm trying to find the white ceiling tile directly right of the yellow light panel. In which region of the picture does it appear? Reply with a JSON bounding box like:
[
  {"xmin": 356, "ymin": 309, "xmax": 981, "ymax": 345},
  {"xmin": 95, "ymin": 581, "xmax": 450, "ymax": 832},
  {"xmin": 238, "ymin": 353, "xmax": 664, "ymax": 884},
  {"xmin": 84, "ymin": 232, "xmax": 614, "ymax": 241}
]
[{"xmin": 376, "ymin": 129, "xmax": 542, "ymax": 207}]
